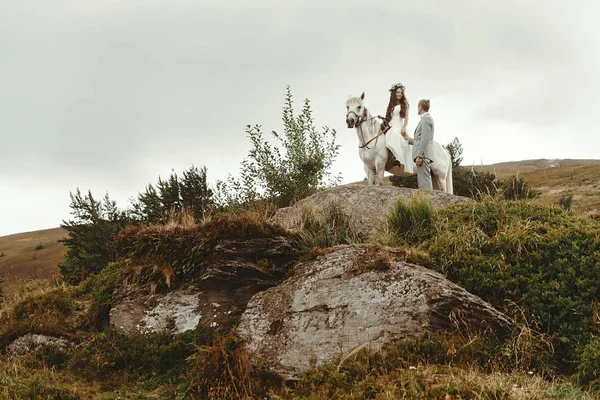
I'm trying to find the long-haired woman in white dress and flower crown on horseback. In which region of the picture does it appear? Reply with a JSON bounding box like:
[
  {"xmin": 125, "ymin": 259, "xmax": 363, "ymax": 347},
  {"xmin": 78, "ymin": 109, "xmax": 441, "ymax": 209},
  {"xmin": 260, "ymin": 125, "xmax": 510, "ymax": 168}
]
[{"xmin": 385, "ymin": 83, "xmax": 414, "ymax": 174}]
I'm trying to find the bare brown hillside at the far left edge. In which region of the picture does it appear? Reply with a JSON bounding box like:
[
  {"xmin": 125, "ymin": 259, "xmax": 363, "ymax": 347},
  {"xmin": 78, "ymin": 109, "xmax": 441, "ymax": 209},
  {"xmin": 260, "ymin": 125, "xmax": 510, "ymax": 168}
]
[{"xmin": 0, "ymin": 228, "xmax": 67, "ymax": 286}]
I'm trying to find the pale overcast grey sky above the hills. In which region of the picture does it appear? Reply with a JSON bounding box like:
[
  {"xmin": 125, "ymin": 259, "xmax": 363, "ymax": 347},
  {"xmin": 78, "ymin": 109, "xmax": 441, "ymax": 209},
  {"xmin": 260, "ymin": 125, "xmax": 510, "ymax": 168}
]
[{"xmin": 0, "ymin": 0, "xmax": 600, "ymax": 236}]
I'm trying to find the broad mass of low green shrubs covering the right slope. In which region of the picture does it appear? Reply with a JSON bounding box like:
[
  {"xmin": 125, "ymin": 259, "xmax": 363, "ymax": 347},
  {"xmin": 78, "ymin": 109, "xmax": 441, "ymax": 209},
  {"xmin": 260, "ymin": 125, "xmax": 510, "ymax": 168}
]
[{"xmin": 420, "ymin": 197, "xmax": 600, "ymax": 372}]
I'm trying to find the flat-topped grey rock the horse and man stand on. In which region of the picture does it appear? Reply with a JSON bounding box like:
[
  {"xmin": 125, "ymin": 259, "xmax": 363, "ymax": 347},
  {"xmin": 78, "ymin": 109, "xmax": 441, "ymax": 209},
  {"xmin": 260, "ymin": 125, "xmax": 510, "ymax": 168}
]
[{"xmin": 272, "ymin": 183, "xmax": 473, "ymax": 235}]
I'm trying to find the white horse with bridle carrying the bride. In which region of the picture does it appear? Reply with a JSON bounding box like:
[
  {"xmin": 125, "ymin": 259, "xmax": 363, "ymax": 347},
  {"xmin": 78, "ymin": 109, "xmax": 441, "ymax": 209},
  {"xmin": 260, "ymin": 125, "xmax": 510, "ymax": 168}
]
[{"xmin": 346, "ymin": 92, "xmax": 453, "ymax": 194}]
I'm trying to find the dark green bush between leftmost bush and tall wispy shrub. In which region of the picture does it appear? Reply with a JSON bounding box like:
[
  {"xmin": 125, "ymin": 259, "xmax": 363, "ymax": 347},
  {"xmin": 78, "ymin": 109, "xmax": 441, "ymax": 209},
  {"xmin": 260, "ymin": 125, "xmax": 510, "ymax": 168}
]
[{"xmin": 133, "ymin": 166, "xmax": 214, "ymax": 224}]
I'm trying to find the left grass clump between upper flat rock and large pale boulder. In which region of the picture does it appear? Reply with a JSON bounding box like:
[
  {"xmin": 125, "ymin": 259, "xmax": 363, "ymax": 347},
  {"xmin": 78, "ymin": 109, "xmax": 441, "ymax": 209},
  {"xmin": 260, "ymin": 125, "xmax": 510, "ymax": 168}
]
[{"xmin": 301, "ymin": 202, "xmax": 361, "ymax": 249}]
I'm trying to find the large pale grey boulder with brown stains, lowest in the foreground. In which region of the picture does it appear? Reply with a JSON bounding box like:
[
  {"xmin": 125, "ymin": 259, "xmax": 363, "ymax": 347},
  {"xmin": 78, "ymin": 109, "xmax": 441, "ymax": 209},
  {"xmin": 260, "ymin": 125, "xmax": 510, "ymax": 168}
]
[{"xmin": 237, "ymin": 246, "xmax": 510, "ymax": 379}]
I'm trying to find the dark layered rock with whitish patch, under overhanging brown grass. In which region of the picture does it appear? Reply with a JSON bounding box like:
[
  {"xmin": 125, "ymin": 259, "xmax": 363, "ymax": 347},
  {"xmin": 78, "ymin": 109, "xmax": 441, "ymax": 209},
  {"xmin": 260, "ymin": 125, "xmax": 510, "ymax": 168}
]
[{"xmin": 110, "ymin": 237, "xmax": 298, "ymax": 335}]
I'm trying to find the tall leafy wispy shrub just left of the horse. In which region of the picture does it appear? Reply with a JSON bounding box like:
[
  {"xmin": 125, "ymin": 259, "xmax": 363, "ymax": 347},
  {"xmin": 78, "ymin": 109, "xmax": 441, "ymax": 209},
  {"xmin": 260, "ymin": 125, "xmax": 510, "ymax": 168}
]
[{"xmin": 217, "ymin": 86, "xmax": 340, "ymax": 207}]
